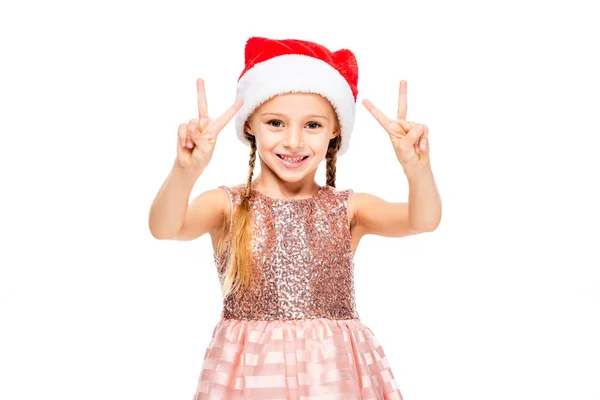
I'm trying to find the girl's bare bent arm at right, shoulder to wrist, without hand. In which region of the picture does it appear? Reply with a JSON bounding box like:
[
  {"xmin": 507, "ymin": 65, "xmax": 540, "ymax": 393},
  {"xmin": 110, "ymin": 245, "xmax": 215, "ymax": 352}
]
[{"xmin": 349, "ymin": 165, "xmax": 441, "ymax": 237}]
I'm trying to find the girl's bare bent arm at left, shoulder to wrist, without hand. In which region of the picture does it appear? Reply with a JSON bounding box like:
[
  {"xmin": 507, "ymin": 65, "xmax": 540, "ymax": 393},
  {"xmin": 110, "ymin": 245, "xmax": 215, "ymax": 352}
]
[{"xmin": 148, "ymin": 159, "xmax": 229, "ymax": 240}]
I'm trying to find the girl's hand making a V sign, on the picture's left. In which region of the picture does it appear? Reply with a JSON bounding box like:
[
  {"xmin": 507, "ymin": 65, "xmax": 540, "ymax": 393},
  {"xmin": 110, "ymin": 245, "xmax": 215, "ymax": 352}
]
[{"xmin": 177, "ymin": 79, "xmax": 244, "ymax": 171}]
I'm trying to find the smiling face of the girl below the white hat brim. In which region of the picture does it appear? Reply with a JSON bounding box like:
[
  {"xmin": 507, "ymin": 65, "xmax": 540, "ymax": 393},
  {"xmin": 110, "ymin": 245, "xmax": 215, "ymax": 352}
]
[{"xmin": 246, "ymin": 93, "xmax": 339, "ymax": 182}]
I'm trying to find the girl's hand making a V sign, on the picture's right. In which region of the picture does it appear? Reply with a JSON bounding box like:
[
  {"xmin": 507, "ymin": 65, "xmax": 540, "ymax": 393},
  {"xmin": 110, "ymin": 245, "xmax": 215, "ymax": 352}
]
[{"xmin": 363, "ymin": 80, "xmax": 429, "ymax": 171}]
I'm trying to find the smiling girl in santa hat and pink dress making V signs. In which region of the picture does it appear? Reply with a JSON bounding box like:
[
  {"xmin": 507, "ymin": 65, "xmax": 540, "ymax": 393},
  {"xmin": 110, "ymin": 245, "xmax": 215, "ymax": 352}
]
[{"xmin": 149, "ymin": 37, "xmax": 441, "ymax": 400}]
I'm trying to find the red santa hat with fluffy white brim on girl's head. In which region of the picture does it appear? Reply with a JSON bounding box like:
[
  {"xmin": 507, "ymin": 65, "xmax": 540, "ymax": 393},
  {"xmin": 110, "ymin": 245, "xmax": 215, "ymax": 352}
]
[{"xmin": 235, "ymin": 37, "xmax": 358, "ymax": 155}]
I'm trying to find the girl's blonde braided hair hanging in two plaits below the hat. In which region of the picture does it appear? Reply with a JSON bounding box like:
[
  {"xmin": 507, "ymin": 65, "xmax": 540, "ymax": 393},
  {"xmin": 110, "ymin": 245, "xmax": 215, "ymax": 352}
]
[{"xmin": 219, "ymin": 115, "xmax": 342, "ymax": 297}]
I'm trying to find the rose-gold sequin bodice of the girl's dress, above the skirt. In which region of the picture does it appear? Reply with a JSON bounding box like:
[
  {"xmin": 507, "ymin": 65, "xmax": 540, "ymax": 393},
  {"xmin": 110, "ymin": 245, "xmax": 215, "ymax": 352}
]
[{"xmin": 215, "ymin": 185, "xmax": 359, "ymax": 320}]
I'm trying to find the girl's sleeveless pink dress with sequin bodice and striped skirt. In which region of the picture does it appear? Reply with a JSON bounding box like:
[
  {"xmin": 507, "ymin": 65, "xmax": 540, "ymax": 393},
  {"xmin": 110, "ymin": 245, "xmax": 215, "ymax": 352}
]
[{"xmin": 193, "ymin": 185, "xmax": 402, "ymax": 400}]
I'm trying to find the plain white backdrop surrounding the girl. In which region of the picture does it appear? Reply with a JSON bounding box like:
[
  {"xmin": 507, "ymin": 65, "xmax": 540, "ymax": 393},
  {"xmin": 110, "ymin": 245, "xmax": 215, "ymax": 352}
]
[{"xmin": 0, "ymin": 0, "xmax": 600, "ymax": 400}]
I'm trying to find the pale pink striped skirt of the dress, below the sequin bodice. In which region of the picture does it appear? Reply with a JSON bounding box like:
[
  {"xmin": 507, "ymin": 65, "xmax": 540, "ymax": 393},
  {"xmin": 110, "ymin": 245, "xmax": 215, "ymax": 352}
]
[{"xmin": 193, "ymin": 318, "xmax": 402, "ymax": 400}]
